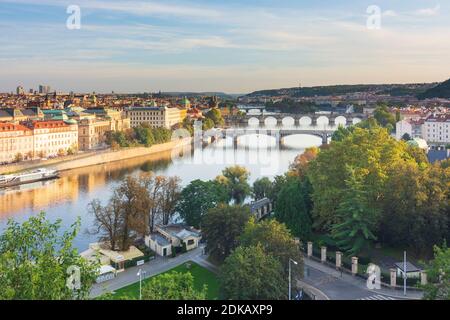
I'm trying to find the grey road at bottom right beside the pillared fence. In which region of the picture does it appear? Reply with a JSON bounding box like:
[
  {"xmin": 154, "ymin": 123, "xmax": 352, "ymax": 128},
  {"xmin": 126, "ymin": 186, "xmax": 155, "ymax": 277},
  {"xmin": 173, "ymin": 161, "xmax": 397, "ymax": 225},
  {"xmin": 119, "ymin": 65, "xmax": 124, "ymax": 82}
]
[{"xmin": 303, "ymin": 258, "xmax": 422, "ymax": 300}]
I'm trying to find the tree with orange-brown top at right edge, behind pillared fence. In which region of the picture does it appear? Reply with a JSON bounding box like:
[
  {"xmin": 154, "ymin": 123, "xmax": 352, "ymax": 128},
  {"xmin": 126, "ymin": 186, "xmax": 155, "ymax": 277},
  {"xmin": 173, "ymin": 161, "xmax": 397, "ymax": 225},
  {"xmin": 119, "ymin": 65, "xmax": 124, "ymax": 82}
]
[{"xmin": 379, "ymin": 162, "xmax": 450, "ymax": 256}]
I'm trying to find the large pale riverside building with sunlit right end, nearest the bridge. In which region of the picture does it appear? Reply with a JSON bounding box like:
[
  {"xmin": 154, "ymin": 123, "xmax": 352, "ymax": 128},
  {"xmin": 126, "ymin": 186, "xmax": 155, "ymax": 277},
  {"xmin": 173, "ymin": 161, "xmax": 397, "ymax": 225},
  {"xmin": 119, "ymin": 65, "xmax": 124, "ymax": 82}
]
[{"xmin": 126, "ymin": 107, "xmax": 182, "ymax": 129}]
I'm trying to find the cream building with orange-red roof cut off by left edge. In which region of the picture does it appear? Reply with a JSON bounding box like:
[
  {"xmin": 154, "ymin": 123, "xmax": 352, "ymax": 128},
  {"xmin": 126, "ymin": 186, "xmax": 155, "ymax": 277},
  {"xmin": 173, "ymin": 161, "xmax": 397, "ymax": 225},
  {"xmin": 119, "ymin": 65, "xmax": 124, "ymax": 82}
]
[{"xmin": 0, "ymin": 123, "xmax": 34, "ymax": 163}]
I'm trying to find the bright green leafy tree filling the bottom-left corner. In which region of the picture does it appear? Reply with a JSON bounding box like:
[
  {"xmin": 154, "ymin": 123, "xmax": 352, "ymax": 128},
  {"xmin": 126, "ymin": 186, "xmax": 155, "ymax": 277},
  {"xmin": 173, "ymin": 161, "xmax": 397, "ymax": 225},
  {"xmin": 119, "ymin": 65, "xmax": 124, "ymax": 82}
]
[{"xmin": 0, "ymin": 213, "xmax": 99, "ymax": 300}]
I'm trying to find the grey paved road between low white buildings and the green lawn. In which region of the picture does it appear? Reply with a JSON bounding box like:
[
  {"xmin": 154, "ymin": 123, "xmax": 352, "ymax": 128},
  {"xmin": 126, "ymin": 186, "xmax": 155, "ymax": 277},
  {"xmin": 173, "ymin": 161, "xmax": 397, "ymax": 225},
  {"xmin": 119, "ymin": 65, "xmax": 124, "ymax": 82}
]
[{"xmin": 90, "ymin": 247, "xmax": 213, "ymax": 298}]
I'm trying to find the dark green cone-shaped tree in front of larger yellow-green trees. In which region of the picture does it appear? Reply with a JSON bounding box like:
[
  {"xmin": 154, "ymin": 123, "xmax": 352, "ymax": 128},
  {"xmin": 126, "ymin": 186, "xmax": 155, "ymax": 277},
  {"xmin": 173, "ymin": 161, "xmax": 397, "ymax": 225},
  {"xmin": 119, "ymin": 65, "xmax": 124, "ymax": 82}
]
[{"xmin": 331, "ymin": 170, "xmax": 379, "ymax": 255}]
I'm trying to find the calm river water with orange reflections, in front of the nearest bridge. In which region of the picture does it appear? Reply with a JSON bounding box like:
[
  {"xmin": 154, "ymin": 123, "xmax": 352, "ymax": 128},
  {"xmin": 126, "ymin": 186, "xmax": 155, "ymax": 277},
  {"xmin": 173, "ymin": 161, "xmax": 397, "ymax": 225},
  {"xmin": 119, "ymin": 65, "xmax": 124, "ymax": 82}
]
[{"xmin": 0, "ymin": 135, "xmax": 321, "ymax": 250}]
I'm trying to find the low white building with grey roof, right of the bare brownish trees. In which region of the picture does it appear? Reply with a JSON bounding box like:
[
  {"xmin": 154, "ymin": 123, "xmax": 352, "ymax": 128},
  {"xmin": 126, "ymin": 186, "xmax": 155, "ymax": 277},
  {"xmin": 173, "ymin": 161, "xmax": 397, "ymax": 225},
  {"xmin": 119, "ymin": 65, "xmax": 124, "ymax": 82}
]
[{"xmin": 145, "ymin": 224, "xmax": 202, "ymax": 257}]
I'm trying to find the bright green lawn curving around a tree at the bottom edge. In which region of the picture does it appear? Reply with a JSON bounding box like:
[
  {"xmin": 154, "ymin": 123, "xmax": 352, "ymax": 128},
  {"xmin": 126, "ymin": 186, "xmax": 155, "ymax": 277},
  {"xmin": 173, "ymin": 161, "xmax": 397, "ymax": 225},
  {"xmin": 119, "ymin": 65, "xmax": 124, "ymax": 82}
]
[{"xmin": 114, "ymin": 261, "xmax": 219, "ymax": 300}]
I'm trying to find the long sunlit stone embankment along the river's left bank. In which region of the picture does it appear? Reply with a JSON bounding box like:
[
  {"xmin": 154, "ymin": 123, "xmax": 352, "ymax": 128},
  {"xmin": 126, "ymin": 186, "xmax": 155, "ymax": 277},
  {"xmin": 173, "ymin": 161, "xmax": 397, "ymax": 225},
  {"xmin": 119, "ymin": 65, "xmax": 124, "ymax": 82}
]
[{"xmin": 0, "ymin": 138, "xmax": 192, "ymax": 174}]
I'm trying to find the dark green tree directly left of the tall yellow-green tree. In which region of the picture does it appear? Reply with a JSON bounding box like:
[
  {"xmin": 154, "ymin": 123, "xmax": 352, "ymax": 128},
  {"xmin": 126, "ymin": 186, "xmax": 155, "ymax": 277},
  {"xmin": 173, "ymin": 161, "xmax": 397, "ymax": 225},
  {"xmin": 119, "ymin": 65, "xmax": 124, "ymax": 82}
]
[{"xmin": 275, "ymin": 177, "xmax": 312, "ymax": 241}]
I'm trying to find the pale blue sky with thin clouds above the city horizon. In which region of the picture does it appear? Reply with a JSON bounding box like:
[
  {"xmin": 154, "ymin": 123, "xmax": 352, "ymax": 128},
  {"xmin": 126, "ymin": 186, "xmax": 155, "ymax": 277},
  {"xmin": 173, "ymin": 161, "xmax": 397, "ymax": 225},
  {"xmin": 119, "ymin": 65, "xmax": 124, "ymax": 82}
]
[{"xmin": 0, "ymin": 0, "xmax": 450, "ymax": 93}]
